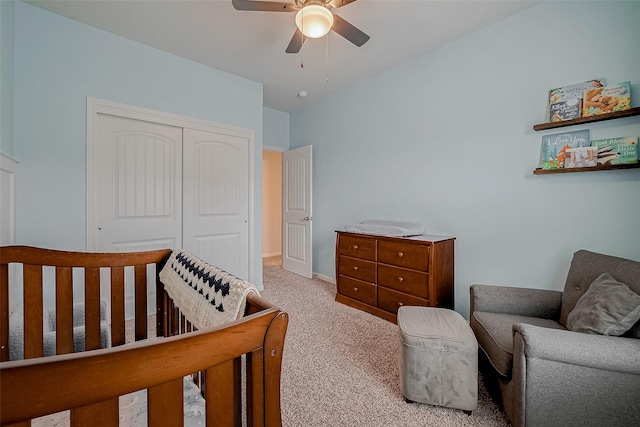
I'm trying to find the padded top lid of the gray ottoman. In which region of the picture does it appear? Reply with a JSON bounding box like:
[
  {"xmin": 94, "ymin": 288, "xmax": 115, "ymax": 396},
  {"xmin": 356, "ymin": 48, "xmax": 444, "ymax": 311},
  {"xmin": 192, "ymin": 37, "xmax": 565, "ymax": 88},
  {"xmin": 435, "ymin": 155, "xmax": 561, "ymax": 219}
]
[{"xmin": 398, "ymin": 306, "xmax": 476, "ymax": 345}]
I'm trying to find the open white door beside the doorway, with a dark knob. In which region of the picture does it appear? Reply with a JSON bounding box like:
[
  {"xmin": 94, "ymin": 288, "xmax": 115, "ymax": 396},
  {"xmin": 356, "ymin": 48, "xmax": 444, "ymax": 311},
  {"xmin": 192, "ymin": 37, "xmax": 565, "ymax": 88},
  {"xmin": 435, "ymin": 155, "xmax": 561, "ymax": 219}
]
[{"xmin": 282, "ymin": 145, "xmax": 313, "ymax": 278}]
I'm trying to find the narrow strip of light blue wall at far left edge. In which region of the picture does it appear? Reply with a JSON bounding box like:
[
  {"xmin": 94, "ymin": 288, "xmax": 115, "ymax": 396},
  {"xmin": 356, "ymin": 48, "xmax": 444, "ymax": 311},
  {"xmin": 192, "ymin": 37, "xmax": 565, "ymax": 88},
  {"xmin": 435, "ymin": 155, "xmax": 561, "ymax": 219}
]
[{"xmin": 0, "ymin": 0, "xmax": 15, "ymax": 156}]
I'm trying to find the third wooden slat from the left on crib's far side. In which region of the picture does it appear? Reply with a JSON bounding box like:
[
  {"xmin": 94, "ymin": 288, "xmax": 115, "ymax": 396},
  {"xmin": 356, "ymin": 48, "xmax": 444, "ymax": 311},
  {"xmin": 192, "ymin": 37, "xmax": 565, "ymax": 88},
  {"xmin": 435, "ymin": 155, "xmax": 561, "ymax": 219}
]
[{"xmin": 56, "ymin": 267, "xmax": 73, "ymax": 354}]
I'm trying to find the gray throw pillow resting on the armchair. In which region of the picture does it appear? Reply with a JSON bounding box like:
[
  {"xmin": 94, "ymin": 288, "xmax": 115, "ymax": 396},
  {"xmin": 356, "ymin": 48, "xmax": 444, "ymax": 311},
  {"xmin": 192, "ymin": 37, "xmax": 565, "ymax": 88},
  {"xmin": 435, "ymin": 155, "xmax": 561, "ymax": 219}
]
[{"xmin": 567, "ymin": 273, "xmax": 640, "ymax": 336}]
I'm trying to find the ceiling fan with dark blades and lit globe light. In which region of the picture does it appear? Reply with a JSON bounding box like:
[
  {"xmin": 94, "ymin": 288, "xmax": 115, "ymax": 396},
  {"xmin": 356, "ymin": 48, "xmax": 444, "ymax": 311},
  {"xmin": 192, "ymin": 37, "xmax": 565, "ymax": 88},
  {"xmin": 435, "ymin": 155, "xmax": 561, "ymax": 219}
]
[{"xmin": 232, "ymin": 0, "xmax": 369, "ymax": 53}]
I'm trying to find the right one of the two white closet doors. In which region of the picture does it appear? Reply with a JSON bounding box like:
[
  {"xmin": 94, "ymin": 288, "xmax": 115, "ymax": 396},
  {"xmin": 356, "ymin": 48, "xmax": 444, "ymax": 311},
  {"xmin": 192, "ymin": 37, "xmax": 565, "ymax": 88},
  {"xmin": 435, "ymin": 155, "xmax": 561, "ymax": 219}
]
[{"xmin": 183, "ymin": 129, "xmax": 249, "ymax": 280}]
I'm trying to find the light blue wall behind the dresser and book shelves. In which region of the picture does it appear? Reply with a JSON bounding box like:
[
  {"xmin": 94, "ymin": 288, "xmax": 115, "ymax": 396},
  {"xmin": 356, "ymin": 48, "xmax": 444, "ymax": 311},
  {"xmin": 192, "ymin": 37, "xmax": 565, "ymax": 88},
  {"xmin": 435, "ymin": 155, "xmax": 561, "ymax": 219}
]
[{"xmin": 290, "ymin": 2, "xmax": 640, "ymax": 316}]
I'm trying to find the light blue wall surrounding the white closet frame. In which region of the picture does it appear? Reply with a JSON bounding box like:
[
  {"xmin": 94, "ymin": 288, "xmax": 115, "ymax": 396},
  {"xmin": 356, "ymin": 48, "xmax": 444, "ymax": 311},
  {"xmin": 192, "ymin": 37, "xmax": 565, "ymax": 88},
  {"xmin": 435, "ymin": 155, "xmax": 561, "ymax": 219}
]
[{"xmin": 14, "ymin": 2, "xmax": 263, "ymax": 286}]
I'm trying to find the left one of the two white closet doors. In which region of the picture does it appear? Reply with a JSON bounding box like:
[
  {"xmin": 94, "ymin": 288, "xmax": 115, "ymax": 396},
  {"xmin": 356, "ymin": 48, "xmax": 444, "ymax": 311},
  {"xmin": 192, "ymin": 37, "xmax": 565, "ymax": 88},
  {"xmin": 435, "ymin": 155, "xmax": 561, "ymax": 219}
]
[{"xmin": 88, "ymin": 114, "xmax": 182, "ymax": 252}]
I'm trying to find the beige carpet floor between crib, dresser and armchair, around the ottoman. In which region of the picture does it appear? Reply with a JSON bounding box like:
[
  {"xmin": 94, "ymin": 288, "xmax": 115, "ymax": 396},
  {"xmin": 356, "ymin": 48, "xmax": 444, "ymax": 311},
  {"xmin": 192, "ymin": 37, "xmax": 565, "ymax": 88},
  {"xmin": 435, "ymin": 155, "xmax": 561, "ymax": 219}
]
[{"xmin": 261, "ymin": 263, "xmax": 509, "ymax": 427}]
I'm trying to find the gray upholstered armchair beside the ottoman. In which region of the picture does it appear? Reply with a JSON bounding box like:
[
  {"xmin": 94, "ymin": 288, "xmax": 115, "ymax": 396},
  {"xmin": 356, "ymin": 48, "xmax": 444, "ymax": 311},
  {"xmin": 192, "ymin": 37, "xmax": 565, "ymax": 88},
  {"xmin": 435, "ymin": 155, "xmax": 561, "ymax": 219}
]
[{"xmin": 470, "ymin": 250, "xmax": 640, "ymax": 427}]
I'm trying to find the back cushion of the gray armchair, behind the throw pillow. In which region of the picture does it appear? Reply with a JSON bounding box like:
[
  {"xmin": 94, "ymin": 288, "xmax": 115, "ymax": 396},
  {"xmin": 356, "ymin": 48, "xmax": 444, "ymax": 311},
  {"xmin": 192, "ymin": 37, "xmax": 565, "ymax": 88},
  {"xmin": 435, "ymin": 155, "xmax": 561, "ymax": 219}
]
[{"xmin": 560, "ymin": 250, "xmax": 640, "ymax": 338}]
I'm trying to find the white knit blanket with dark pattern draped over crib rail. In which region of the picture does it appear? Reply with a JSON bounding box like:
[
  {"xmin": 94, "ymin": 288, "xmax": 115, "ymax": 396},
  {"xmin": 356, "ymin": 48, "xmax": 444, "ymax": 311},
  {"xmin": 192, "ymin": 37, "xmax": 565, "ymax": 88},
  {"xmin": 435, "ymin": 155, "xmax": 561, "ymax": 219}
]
[{"xmin": 160, "ymin": 249, "xmax": 259, "ymax": 329}]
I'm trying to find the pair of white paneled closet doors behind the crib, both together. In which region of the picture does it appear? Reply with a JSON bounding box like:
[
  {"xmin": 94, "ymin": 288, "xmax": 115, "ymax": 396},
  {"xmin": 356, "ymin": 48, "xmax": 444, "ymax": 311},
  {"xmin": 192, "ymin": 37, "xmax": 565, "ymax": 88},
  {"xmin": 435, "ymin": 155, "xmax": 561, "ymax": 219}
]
[{"xmin": 88, "ymin": 114, "xmax": 249, "ymax": 279}]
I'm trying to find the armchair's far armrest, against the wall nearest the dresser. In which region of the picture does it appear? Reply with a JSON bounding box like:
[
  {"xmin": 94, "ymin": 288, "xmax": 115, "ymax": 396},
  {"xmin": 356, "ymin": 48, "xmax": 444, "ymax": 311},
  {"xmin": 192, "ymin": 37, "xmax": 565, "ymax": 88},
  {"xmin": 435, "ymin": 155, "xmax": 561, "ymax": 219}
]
[{"xmin": 470, "ymin": 285, "xmax": 562, "ymax": 320}]
